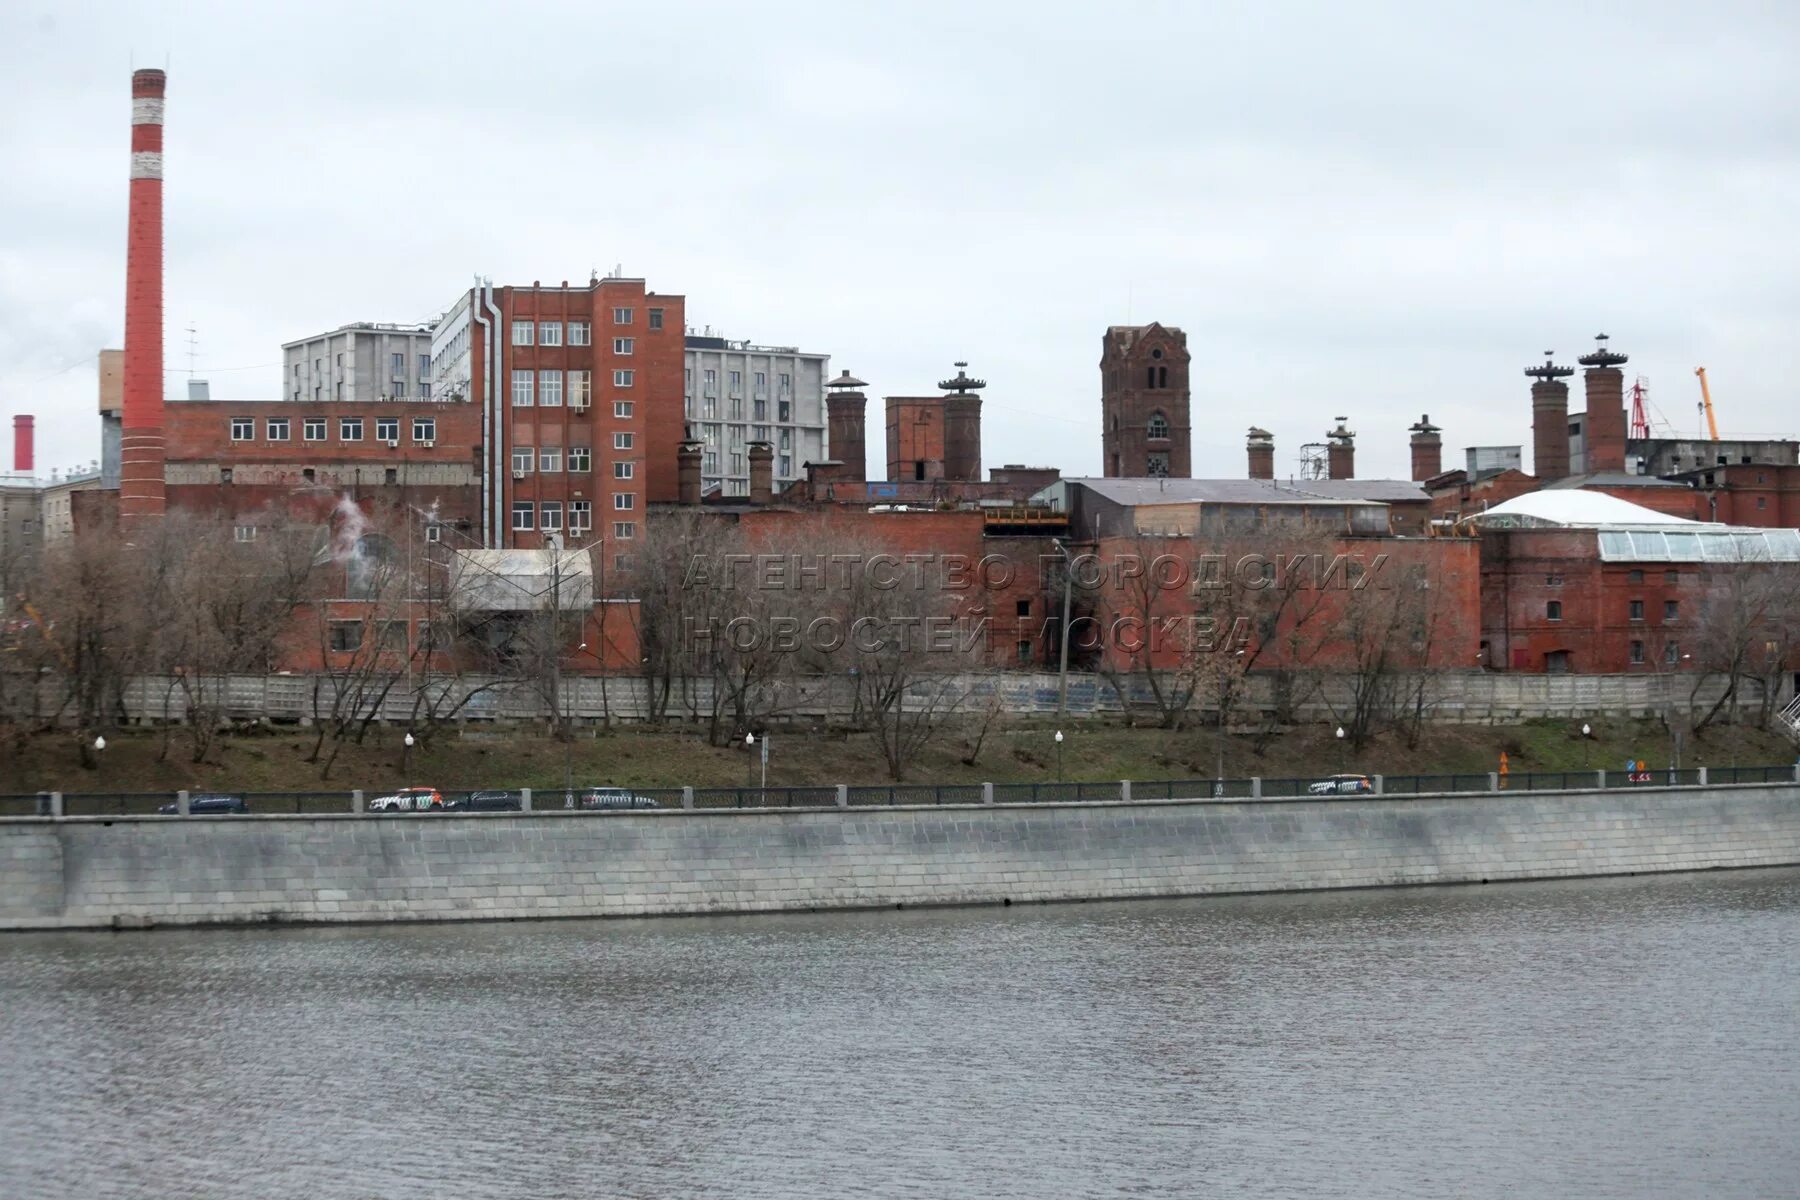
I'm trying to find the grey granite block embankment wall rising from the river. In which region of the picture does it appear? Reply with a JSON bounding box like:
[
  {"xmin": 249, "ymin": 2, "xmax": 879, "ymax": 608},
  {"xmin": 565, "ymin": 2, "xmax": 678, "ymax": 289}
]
[{"xmin": 0, "ymin": 784, "xmax": 1800, "ymax": 928}]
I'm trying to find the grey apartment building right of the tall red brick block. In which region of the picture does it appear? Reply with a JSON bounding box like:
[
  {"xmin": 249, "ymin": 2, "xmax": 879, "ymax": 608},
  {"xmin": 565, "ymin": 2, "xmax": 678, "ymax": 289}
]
[{"xmin": 684, "ymin": 333, "xmax": 832, "ymax": 497}]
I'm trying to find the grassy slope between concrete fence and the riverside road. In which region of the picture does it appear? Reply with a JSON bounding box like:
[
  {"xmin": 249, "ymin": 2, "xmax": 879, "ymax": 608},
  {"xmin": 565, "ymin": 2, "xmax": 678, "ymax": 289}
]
[{"xmin": 0, "ymin": 720, "xmax": 1795, "ymax": 792}]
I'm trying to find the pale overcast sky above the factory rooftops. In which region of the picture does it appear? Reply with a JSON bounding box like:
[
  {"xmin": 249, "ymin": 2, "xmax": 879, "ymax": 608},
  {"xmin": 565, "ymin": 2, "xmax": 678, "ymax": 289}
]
[{"xmin": 0, "ymin": 0, "xmax": 1800, "ymax": 477}]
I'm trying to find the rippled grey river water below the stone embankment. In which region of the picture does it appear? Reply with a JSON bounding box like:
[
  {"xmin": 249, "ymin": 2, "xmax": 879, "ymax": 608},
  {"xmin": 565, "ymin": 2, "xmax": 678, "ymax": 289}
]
[{"xmin": 0, "ymin": 871, "xmax": 1800, "ymax": 1200}]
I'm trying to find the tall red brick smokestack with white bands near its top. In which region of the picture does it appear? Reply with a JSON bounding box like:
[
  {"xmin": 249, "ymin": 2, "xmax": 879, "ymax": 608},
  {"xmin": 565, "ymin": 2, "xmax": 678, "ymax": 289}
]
[{"xmin": 119, "ymin": 70, "xmax": 167, "ymax": 520}]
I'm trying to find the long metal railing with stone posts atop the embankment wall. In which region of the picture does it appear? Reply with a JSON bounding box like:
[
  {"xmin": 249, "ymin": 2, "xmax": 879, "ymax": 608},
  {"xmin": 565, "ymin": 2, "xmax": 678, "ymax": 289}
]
[{"xmin": 0, "ymin": 763, "xmax": 1800, "ymax": 817}]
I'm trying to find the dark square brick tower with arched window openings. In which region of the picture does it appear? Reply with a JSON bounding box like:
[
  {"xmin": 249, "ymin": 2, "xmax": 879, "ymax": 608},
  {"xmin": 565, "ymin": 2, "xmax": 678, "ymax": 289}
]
[{"xmin": 1100, "ymin": 322, "xmax": 1193, "ymax": 479}]
